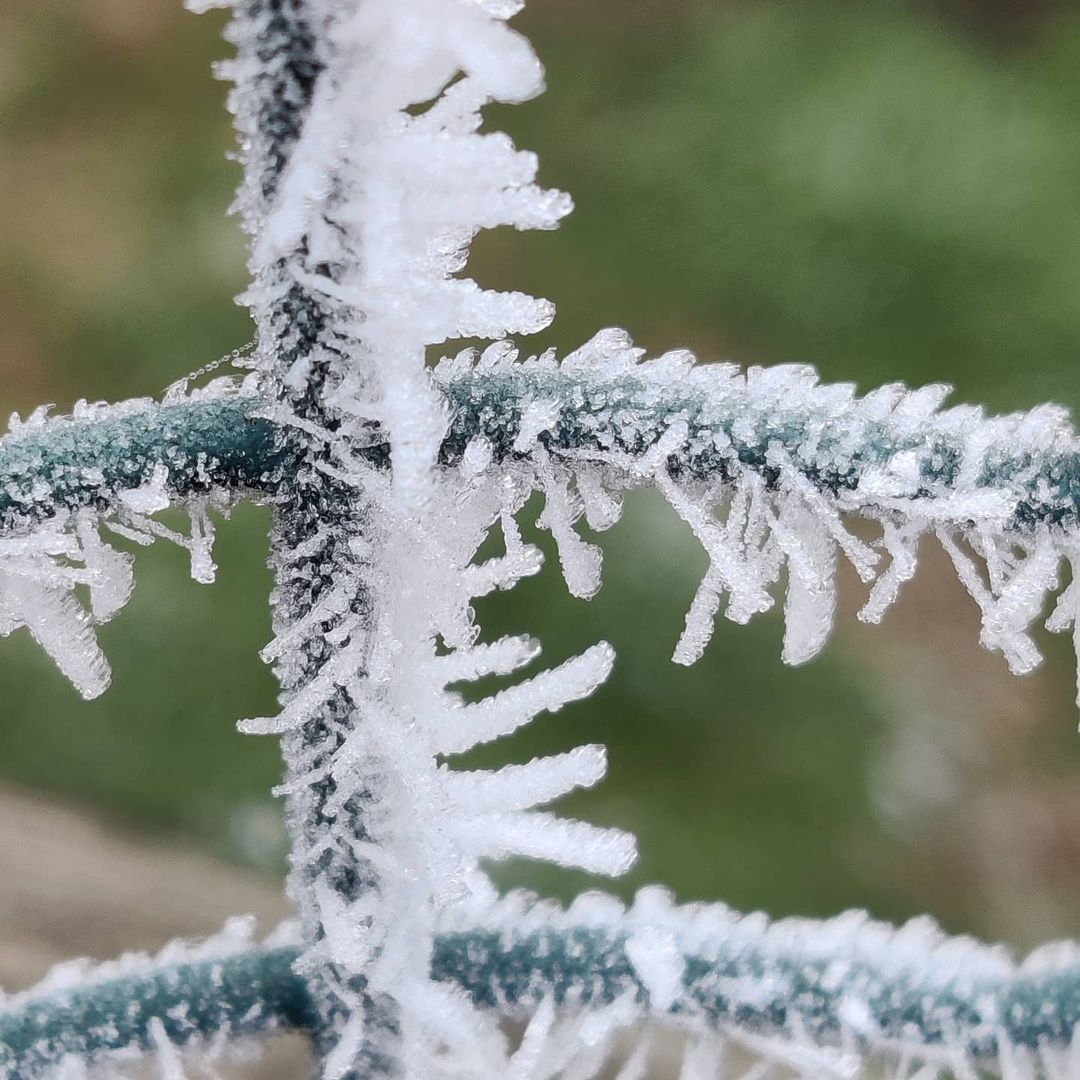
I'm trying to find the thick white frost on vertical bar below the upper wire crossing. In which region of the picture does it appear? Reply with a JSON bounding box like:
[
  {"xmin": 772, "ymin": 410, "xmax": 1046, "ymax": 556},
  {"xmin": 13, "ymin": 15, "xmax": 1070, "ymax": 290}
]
[{"xmin": 257, "ymin": 470, "xmax": 634, "ymax": 1077}]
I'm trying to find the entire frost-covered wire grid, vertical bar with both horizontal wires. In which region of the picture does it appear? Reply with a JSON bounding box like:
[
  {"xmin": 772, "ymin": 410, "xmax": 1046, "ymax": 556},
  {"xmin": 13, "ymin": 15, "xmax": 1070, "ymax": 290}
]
[{"xmin": 0, "ymin": 0, "xmax": 1080, "ymax": 1080}]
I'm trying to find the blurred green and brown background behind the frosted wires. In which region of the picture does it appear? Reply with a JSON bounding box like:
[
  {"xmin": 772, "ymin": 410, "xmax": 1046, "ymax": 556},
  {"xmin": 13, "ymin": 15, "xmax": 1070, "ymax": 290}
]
[{"xmin": 0, "ymin": 0, "xmax": 1080, "ymax": 944}]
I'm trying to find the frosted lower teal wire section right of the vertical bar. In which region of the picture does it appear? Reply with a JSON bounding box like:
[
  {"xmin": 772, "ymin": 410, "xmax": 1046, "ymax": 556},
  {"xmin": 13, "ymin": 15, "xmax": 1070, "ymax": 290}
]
[{"xmin": 419, "ymin": 888, "xmax": 1080, "ymax": 1080}]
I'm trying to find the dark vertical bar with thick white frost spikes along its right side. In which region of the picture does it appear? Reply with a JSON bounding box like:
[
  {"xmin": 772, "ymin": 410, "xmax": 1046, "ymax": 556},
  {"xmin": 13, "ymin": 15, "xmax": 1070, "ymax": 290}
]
[{"xmin": 228, "ymin": 0, "xmax": 634, "ymax": 1078}]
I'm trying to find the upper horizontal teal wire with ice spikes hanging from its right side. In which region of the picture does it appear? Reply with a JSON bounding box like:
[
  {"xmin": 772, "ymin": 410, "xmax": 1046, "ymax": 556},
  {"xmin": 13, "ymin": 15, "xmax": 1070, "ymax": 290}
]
[{"xmin": 8, "ymin": 347, "xmax": 1080, "ymax": 699}]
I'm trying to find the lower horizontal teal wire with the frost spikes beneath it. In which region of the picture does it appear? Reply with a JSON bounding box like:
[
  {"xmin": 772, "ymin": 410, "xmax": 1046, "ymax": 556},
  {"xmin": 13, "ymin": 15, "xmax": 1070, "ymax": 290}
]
[{"xmin": 10, "ymin": 889, "xmax": 1080, "ymax": 1080}]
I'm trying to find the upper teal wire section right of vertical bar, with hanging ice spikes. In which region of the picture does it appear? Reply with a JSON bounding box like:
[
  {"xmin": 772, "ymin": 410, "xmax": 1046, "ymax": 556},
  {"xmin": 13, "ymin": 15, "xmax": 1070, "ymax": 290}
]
[{"xmin": 436, "ymin": 329, "xmax": 1080, "ymax": 712}]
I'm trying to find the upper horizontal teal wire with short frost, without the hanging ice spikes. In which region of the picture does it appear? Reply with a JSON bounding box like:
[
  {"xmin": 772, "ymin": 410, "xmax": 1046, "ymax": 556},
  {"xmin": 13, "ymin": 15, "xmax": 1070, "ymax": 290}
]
[{"xmin": 12, "ymin": 360, "xmax": 1080, "ymax": 532}]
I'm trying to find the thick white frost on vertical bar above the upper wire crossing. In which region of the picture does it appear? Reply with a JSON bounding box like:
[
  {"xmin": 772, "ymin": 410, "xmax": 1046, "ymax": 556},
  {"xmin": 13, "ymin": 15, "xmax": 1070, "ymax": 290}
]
[{"xmin": 224, "ymin": 0, "xmax": 571, "ymax": 509}]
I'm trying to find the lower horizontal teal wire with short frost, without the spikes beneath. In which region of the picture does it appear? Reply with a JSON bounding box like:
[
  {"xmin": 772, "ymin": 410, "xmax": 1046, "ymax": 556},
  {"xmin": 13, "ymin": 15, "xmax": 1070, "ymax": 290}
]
[{"xmin": 10, "ymin": 890, "xmax": 1080, "ymax": 1077}]
